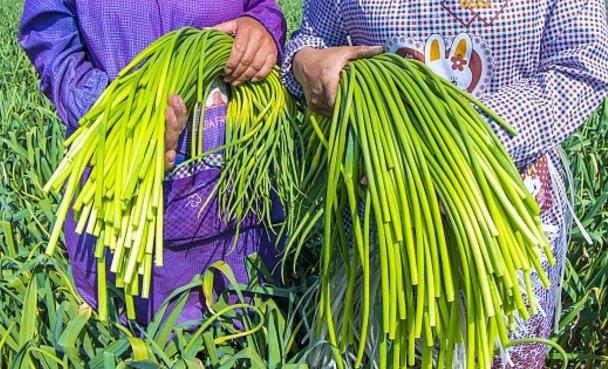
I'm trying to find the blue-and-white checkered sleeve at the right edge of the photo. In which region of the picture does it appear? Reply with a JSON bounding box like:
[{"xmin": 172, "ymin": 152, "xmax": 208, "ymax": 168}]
[{"xmin": 483, "ymin": 0, "xmax": 608, "ymax": 168}]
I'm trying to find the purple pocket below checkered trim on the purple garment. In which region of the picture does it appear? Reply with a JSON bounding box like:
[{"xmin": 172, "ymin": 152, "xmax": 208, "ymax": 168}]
[{"xmin": 163, "ymin": 163, "xmax": 221, "ymax": 246}]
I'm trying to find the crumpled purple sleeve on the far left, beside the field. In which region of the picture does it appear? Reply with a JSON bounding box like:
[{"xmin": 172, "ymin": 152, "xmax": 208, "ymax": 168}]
[{"xmin": 19, "ymin": 0, "xmax": 108, "ymax": 131}]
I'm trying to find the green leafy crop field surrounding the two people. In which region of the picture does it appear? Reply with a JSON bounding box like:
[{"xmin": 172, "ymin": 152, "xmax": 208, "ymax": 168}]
[{"xmin": 0, "ymin": 0, "xmax": 608, "ymax": 369}]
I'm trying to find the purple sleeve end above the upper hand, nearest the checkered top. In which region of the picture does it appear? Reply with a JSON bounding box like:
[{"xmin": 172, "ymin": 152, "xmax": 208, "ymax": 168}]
[{"xmin": 243, "ymin": 0, "xmax": 287, "ymax": 55}]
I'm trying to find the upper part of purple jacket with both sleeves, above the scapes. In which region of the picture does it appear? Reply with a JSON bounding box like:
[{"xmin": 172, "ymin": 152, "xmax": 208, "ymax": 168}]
[{"xmin": 19, "ymin": 0, "xmax": 286, "ymax": 134}]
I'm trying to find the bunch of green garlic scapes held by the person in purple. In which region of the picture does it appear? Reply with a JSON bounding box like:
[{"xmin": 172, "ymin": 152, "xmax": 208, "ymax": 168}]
[{"xmin": 44, "ymin": 27, "xmax": 299, "ymax": 321}]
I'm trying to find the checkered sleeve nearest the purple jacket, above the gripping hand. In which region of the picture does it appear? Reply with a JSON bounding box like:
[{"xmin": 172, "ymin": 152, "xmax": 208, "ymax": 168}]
[{"xmin": 281, "ymin": 0, "xmax": 346, "ymax": 97}]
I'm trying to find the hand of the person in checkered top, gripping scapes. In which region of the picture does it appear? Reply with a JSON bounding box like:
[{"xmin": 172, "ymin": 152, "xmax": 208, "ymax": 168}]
[{"xmin": 293, "ymin": 46, "xmax": 384, "ymax": 117}]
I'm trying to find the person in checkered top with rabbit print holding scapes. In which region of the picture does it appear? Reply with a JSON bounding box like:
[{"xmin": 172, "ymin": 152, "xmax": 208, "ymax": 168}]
[{"xmin": 282, "ymin": 0, "xmax": 608, "ymax": 369}]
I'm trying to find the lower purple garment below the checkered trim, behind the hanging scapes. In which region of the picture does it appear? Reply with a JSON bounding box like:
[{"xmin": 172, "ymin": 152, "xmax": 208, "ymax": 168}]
[{"xmin": 64, "ymin": 165, "xmax": 280, "ymax": 324}]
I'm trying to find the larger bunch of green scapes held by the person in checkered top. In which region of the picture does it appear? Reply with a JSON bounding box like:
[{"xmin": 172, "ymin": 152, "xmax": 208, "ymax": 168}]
[{"xmin": 283, "ymin": 54, "xmax": 555, "ymax": 369}]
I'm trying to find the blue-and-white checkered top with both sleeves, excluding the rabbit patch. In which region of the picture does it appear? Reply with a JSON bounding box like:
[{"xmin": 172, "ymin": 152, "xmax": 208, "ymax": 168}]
[{"xmin": 283, "ymin": 0, "xmax": 608, "ymax": 168}]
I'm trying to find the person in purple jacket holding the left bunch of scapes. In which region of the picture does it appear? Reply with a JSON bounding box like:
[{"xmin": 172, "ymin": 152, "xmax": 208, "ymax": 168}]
[{"xmin": 19, "ymin": 0, "xmax": 286, "ymax": 324}]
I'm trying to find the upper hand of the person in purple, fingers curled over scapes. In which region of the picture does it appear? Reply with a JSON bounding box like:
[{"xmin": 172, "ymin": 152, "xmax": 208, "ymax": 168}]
[{"xmin": 216, "ymin": 17, "xmax": 278, "ymax": 86}]
